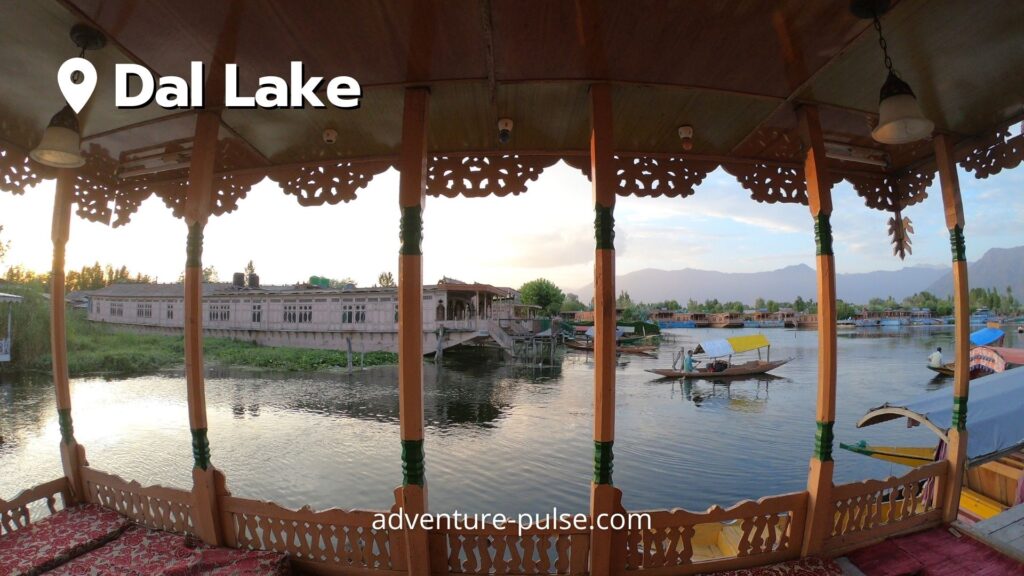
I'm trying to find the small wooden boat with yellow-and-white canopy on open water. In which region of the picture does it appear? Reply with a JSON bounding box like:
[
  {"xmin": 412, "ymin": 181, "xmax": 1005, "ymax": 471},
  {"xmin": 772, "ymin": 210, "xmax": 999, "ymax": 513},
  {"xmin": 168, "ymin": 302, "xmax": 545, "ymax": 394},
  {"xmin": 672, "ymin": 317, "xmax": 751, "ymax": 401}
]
[{"xmin": 647, "ymin": 334, "xmax": 792, "ymax": 379}]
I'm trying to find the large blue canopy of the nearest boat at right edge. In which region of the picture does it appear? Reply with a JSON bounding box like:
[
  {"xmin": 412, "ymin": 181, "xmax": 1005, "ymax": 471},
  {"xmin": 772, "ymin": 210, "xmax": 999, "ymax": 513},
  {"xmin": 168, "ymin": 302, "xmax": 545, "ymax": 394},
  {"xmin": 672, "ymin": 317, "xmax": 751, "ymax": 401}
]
[{"xmin": 857, "ymin": 370, "xmax": 1024, "ymax": 465}]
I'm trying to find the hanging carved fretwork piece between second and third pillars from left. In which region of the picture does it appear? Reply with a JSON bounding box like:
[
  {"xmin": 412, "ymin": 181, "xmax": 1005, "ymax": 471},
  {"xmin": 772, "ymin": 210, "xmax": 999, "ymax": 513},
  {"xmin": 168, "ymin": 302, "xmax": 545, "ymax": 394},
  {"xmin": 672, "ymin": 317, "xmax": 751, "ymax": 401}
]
[{"xmin": 267, "ymin": 161, "xmax": 391, "ymax": 206}]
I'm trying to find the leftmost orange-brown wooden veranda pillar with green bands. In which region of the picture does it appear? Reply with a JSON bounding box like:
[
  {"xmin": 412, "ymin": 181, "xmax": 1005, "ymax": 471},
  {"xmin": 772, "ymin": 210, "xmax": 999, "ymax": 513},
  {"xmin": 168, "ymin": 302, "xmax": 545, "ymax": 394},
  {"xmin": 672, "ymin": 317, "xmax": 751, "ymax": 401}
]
[{"xmin": 50, "ymin": 168, "xmax": 87, "ymax": 503}]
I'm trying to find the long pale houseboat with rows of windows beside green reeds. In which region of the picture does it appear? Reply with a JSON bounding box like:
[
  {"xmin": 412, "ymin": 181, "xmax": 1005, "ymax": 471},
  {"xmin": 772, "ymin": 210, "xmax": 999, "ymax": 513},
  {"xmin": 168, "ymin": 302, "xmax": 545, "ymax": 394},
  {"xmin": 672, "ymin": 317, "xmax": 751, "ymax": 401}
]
[{"xmin": 88, "ymin": 279, "xmax": 520, "ymax": 353}]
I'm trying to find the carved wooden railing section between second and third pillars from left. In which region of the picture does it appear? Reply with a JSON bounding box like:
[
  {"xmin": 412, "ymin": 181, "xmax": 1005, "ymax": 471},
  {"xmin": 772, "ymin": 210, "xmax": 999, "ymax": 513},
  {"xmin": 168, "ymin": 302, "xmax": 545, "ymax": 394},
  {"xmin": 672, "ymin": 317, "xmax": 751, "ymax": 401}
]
[{"xmin": 220, "ymin": 496, "xmax": 406, "ymax": 574}]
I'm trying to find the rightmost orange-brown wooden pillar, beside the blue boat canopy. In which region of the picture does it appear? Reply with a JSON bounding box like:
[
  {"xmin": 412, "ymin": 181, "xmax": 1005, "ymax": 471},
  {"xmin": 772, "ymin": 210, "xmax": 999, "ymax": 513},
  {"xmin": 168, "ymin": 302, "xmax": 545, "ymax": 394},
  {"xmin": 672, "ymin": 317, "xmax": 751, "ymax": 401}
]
[{"xmin": 935, "ymin": 134, "xmax": 971, "ymax": 523}]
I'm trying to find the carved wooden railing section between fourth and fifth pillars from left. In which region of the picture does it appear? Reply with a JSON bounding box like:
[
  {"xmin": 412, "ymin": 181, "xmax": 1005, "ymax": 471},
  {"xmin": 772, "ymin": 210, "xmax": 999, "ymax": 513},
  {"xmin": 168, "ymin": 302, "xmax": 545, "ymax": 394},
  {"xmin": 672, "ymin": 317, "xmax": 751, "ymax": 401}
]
[{"xmin": 615, "ymin": 492, "xmax": 807, "ymax": 574}]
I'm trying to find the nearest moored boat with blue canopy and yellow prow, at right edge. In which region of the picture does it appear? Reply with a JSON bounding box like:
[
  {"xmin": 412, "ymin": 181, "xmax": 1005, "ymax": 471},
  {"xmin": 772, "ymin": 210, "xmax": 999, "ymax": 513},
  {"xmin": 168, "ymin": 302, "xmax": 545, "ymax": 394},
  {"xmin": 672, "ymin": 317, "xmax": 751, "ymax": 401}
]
[{"xmin": 840, "ymin": 370, "xmax": 1024, "ymax": 522}]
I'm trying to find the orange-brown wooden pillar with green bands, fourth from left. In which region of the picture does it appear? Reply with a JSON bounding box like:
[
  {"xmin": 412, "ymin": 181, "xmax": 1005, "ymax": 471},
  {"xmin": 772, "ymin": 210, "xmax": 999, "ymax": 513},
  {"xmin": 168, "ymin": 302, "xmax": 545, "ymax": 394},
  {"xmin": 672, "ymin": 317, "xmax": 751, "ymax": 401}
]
[{"xmin": 590, "ymin": 84, "xmax": 620, "ymax": 576}]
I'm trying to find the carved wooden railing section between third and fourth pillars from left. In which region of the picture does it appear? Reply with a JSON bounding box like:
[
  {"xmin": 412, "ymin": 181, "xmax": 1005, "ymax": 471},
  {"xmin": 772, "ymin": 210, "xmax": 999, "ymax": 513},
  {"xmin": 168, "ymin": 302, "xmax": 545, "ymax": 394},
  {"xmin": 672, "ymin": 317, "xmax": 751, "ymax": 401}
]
[{"xmin": 430, "ymin": 522, "xmax": 590, "ymax": 576}]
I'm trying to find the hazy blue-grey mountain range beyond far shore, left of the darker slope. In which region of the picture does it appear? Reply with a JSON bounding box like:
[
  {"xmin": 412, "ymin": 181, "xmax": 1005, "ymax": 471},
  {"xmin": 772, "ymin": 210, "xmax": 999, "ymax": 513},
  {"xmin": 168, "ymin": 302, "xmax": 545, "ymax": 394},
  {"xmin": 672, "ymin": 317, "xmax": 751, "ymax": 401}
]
[{"xmin": 577, "ymin": 264, "xmax": 946, "ymax": 304}]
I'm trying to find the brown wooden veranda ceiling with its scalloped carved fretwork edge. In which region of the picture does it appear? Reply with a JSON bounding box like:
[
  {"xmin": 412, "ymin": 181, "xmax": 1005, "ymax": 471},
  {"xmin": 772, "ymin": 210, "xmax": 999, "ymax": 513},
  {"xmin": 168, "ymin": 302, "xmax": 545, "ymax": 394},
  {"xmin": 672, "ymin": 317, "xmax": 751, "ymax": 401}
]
[{"xmin": 0, "ymin": 0, "xmax": 1024, "ymax": 224}]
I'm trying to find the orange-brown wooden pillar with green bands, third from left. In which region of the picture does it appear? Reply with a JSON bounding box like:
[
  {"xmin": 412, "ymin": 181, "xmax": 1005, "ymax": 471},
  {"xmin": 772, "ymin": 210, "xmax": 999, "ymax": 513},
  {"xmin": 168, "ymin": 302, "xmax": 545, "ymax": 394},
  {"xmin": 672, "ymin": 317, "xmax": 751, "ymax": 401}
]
[{"xmin": 395, "ymin": 88, "xmax": 430, "ymax": 576}]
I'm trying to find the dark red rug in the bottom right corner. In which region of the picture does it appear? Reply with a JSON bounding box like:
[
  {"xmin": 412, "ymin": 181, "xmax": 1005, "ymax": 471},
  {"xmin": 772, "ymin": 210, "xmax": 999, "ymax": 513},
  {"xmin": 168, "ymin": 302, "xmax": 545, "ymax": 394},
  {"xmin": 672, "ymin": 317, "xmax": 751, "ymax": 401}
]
[{"xmin": 847, "ymin": 528, "xmax": 1024, "ymax": 576}]
